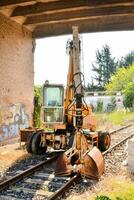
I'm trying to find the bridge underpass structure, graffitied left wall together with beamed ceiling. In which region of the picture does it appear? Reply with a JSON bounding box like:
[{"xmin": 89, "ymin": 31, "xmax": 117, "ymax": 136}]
[{"xmin": 0, "ymin": 0, "xmax": 134, "ymax": 142}]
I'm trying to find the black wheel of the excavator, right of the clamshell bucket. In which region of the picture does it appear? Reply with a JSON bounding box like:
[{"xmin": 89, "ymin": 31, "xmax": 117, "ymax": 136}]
[{"xmin": 98, "ymin": 131, "xmax": 111, "ymax": 151}]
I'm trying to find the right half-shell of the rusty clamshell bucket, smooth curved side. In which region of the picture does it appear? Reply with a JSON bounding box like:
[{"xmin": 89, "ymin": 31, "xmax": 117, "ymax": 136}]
[{"xmin": 80, "ymin": 147, "xmax": 104, "ymax": 179}]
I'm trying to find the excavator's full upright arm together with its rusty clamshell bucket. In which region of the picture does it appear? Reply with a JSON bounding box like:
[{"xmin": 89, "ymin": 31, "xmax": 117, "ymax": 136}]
[{"xmin": 55, "ymin": 27, "xmax": 104, "ymax": 179}]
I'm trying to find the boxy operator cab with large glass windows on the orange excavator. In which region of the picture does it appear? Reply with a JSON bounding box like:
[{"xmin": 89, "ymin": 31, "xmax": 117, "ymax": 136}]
[{"xmin": 42, "ymin": 83, "xmax": 64, "ymax": 124}]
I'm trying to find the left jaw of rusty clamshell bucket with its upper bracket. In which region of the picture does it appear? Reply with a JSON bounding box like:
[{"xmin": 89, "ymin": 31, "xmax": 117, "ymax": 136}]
[{"xmin": 55, "ymin": 132, "xmax": 88, "ymax": 176}]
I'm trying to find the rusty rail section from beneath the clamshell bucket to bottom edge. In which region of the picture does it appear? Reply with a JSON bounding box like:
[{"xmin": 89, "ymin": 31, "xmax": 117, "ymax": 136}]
[{"xmin": 48, "ymin": 173, "xmax": 81, "ymax": 200}]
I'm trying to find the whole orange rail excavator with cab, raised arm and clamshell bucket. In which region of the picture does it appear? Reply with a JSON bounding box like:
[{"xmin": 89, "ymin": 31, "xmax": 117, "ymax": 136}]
[{"xmin": 21, "ymin": 27, "xmax": 110, "ymax": 179}]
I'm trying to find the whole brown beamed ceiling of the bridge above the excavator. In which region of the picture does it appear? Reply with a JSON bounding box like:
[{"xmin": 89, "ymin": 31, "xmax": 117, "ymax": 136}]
[{"xmin": 0, "ymin": 0, "xmax": 134, "ymax": 38}]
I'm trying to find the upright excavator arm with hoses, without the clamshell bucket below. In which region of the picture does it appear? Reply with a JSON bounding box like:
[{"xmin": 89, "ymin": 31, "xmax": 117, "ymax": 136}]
[{"xmin": 65, "ymin": 27, "xmax": 89, "ymax": 128}]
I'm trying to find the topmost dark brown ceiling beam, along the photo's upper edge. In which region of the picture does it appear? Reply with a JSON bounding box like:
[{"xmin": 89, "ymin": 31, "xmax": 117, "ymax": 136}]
[{"xmin": 11, "ymin": 0, "xmax": 134, "ymax": 17}]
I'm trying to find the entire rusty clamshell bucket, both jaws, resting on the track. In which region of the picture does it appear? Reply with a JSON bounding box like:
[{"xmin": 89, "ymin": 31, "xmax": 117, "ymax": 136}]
[{"xmin": 55, "ymin": 132, "xmax": 104, "ymax": 179}]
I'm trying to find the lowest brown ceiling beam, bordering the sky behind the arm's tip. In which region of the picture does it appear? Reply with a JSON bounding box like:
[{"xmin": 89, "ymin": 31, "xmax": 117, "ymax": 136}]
[{"xmin": 33, "ymin": 15, "xmax": 134, "ymax": 38}]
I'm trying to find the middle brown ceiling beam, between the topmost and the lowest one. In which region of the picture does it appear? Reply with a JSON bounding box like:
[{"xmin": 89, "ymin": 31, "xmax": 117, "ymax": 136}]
[{"xmin": 24, "ymin": 5, "xmax": 134, "ymax": 25}]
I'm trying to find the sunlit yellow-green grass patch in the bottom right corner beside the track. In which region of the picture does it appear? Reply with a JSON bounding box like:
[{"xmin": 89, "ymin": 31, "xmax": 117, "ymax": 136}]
[{"xmin": 92, "ymin": 177, "xmax": 134, "ymax": 200}]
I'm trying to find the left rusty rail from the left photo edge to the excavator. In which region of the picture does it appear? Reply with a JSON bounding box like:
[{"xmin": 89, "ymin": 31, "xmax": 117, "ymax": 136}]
[{"xmin": 0, "ymin": 155, "xmax": 58, "ymax": 191}]
